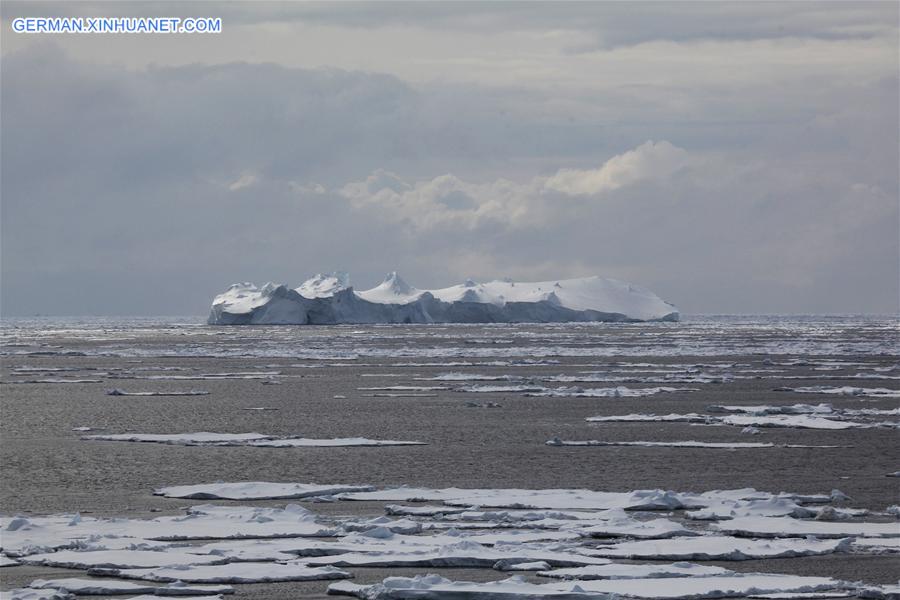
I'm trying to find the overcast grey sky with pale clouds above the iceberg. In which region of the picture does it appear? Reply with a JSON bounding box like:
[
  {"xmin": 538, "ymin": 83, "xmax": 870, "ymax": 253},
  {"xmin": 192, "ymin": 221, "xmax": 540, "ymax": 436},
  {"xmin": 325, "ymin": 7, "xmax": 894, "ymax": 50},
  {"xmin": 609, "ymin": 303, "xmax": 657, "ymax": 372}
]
[{"xmin": 0, "ymin": 1, "xmax": 900, "ymax": 316}]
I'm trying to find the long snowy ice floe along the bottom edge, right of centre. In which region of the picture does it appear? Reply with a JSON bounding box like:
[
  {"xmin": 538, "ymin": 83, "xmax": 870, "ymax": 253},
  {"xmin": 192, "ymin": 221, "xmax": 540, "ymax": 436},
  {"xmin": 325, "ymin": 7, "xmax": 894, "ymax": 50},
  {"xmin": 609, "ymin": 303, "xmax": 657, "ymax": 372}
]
[{"xmin": 328, "ymin": 573, "xmax": 847, "ymax": 600}]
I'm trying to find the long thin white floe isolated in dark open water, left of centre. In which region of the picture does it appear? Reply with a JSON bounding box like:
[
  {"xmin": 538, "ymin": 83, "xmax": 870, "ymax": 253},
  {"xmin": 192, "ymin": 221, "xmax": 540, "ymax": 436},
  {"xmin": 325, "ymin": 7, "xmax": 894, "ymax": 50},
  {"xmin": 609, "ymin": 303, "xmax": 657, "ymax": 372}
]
[{"xmin": 83, "ymin": 434, "xmax": 425, "ymax": 448}]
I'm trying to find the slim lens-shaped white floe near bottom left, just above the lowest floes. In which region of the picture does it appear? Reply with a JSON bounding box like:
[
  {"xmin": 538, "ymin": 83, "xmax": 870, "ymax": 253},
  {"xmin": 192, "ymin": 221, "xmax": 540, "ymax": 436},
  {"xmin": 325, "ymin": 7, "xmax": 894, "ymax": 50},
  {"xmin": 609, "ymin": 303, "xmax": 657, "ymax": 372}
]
[{"xmin": 95, "ymin": 561, "xmax": 350, "ymax": 583}]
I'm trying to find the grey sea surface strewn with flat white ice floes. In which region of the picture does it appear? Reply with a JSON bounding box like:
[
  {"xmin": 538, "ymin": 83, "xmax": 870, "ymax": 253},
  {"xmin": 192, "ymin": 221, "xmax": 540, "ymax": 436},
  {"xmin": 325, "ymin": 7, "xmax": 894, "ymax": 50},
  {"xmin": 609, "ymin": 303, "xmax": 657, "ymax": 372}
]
[{"xmin": 0, "ymin": 317, "xmax": 900, "ymax": 599}]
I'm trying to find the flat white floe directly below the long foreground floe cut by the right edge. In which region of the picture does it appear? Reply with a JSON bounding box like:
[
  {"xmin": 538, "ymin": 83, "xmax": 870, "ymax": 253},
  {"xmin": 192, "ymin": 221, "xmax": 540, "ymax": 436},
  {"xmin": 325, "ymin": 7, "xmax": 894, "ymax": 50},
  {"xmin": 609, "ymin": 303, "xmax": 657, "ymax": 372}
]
[{"xmin": 584, "ymin": 535, "xmax": 851, "ymax": 560}]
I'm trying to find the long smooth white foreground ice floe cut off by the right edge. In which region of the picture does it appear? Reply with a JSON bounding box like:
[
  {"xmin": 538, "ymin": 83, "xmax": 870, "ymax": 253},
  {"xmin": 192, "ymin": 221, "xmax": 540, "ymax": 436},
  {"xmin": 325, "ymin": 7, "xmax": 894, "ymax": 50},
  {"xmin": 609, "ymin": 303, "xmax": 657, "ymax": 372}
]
[{"xmin": 713, "ymin": 517, "xmax": 900, "ymax": 538}]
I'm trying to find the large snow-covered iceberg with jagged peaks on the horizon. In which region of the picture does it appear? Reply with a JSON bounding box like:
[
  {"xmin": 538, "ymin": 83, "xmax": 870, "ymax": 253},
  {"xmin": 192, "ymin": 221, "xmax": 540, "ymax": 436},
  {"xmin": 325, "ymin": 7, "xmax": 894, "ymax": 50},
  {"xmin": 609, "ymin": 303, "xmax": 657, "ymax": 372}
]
[{"xmin": 208, "ymin": 272, "xmax": 679, "ymax": 325}]
